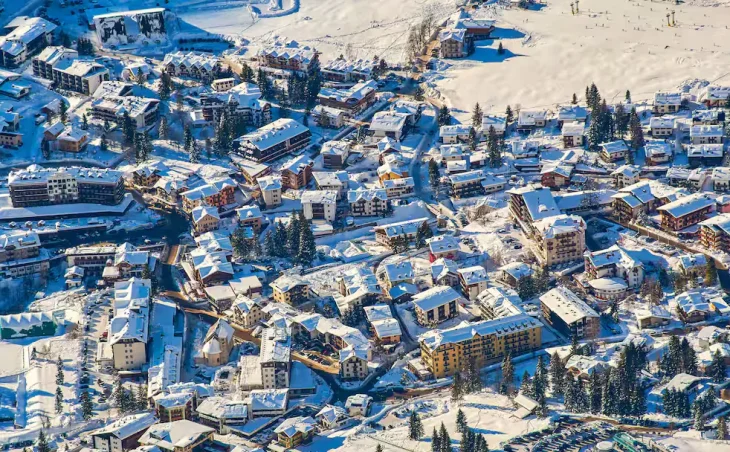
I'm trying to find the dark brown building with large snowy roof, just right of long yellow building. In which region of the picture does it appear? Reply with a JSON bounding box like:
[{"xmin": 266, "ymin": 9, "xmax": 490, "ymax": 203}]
[{"xmin": 540, "ymin": 286, "xmax": 601, "ymax": 339}]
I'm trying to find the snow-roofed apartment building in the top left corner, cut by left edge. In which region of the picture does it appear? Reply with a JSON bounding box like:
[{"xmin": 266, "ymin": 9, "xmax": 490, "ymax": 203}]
[{"xmin": 0, "ymin": 16, "xmax": 57, "ymax": 68}]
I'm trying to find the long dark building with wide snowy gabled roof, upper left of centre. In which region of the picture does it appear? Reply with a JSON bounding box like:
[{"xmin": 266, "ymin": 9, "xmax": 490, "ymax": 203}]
[{"xmin": 233, "ymin": 118, "xmax": 312, "ymax": 162}]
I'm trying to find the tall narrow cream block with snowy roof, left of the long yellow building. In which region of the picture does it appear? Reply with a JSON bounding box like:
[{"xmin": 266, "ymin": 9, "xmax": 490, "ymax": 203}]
[{"xmin": 259, "ymin": 328, "xmax": 291, "ymax": 389}]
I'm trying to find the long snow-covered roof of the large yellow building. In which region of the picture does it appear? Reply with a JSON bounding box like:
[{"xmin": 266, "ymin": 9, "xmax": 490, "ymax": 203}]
[{"xmin": 419, "ymin": 314, "xmax": 542, "ymax": 350}]
